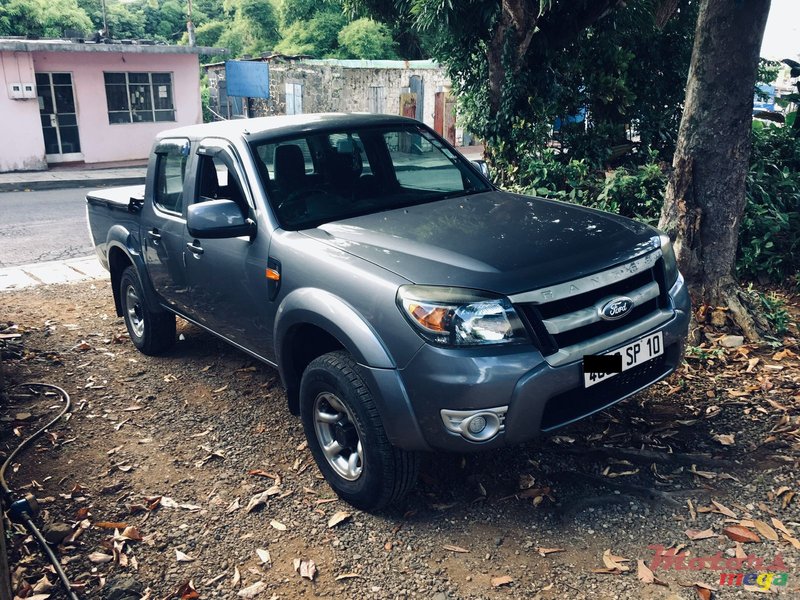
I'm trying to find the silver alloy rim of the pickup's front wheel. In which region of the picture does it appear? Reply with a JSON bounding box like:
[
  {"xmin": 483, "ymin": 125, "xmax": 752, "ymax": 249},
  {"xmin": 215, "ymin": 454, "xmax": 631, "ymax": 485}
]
[{"xmin": 314, "ymin": 392, "xmax": 364, "ymax": 481}]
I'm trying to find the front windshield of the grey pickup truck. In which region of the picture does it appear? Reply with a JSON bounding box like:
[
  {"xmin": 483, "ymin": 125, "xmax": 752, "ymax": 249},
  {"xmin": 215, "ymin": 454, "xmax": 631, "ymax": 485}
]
[{"xmin": 250, "ymin": 125, "xmax": 490, "ymax": 229}]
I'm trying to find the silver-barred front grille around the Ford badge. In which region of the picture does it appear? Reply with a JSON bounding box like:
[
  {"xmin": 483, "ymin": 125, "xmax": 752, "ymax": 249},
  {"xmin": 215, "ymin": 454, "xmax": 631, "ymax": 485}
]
[{"xmin": 511, "ymin": 250, "xmax": 672, "ymax": 365}]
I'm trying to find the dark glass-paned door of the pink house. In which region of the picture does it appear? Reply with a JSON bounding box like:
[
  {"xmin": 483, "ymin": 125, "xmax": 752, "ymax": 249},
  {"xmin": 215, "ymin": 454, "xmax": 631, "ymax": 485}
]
[{"xmin": 36, "ymin": 73, "xmax": 83, "ymax": 163}]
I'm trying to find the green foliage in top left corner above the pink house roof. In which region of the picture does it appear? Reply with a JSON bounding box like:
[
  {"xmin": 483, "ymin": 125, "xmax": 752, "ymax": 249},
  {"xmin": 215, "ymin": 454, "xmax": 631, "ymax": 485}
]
[{"xmin": 0, "ymin": 0, "xmax": 92, "ymax": 37}]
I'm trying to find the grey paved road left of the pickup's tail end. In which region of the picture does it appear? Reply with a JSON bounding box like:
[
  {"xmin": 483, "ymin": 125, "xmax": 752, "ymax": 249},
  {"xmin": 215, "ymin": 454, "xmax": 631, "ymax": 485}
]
[{"xmin": 0, "ymin": 188, "xmax": 93, "ymax": 267}]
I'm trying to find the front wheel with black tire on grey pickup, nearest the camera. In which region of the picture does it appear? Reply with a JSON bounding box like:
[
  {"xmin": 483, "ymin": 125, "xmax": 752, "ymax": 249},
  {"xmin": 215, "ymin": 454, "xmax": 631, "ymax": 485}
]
[{"xmin": 300, "ymin": 352, "xmax": 419, "ymax": 511}]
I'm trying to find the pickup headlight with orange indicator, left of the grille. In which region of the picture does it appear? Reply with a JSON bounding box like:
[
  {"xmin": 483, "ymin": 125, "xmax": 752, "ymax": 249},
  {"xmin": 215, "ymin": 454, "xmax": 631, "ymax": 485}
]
[{"xmin": 397, "ymin": 285, "xmax": 528, "ymax": 346}]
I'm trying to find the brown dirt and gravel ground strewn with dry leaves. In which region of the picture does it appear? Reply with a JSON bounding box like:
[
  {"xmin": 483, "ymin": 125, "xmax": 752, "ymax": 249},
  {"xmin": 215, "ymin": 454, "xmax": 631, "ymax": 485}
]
[{"xmin": 0, "ymin": 282, "xmax": 800, "ymax": 600}]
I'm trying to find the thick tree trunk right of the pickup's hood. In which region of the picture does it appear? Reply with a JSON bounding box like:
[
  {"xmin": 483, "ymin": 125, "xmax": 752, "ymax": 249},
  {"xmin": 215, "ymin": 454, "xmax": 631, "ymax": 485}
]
[{"xmin": 659, "ymin": 0, "xmax": 770, "ymax": 339}]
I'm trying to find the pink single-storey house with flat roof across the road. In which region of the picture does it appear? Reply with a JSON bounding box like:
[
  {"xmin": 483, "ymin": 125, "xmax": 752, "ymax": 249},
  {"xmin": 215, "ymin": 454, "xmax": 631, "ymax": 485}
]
[{"xmin": 0, "ymin": 39, "xmax": 225, "ymax": 172}]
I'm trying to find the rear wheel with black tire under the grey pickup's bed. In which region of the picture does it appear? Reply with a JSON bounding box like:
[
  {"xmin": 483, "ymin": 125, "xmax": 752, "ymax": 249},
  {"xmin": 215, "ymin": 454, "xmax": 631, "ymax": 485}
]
[{"xmin": 119, "ymin": 266, "xmax": 175, "ymax": 355}]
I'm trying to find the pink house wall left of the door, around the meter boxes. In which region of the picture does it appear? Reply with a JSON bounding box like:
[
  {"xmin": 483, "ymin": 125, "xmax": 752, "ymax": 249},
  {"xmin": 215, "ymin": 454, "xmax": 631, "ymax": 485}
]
[{"xmin": 0, "ymin": 52, "xmax": 47, "ymax": 172}]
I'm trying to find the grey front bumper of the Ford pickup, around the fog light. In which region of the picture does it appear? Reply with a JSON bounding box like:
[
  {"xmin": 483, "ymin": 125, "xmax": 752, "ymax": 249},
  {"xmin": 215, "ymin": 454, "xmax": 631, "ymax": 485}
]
[{"xmin": 379, "ymin": 278, "xmax": 690, "ymax": 452}]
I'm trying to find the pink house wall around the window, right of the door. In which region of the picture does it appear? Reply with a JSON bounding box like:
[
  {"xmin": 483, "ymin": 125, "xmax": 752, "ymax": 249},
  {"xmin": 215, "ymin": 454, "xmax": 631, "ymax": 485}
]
[{"xmin": 33, "ymin": 52, "xmax": 203, "ymax": 164}]
